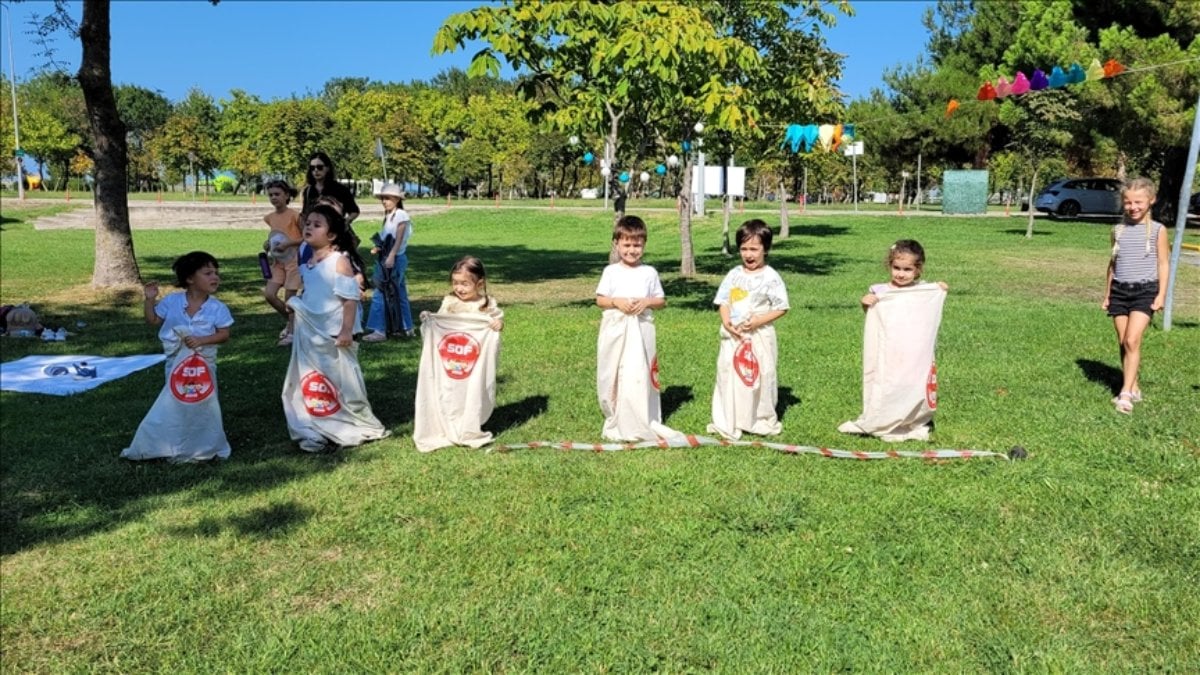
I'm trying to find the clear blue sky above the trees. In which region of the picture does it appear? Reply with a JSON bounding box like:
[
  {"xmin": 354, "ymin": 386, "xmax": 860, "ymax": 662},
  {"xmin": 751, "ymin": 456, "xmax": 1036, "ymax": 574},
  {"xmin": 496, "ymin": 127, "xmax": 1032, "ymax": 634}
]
[{"xmin": 0, "ymin": 0, "xmax": 932, "ymax": 101}]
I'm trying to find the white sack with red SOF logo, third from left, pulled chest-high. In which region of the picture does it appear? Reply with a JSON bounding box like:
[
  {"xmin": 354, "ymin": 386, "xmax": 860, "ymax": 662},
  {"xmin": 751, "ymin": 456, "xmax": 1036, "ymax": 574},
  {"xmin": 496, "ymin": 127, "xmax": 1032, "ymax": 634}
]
[{"xmin": 413, "ymin": 313, "xmax": 503, "ymax": 453}]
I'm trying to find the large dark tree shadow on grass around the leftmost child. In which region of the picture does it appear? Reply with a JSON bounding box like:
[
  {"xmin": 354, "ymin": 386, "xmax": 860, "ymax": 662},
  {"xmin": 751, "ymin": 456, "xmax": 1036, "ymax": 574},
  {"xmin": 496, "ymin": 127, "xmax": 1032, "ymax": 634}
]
[{"xmin": 0, "ymin": 302, "xmax": 381, "ymax": 555}]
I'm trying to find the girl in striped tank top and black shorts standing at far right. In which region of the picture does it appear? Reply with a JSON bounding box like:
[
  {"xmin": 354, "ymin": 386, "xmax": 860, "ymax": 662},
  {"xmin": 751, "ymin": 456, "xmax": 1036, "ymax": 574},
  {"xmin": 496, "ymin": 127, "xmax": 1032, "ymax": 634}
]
[{"xmin": 1100, "ymin": 178, "xmax": 1170, "ymax": 414}]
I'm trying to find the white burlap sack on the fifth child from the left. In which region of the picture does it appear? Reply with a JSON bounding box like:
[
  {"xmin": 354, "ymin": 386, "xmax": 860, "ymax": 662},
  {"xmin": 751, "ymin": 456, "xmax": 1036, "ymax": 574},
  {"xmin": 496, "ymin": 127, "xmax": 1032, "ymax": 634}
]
[{"xmin": 708, "ymin": 325, "xmax": 784, "ymax": 441}]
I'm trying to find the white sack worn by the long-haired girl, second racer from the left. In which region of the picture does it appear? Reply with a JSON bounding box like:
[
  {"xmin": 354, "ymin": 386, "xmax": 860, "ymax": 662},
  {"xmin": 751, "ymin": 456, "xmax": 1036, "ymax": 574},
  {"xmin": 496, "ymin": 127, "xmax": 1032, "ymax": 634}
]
[{"xmin": 283, "ymin": 296, "xmax": 388, "ymax": 452}]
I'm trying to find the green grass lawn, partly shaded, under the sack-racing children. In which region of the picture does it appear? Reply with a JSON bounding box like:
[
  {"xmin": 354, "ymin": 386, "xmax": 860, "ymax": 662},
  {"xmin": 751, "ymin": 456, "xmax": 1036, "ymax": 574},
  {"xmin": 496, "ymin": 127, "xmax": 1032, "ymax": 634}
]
[{"xmin": 0, "ymin": 201, "xmax": 1200, "ymax": 673}]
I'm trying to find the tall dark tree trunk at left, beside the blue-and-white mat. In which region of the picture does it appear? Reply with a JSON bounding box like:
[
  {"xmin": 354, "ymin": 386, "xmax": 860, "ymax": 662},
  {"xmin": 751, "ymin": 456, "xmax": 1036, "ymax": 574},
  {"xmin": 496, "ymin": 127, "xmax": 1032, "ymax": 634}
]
[{"xmin": 78, "ymin": 0, "xmax": 140, "ymax": 288}]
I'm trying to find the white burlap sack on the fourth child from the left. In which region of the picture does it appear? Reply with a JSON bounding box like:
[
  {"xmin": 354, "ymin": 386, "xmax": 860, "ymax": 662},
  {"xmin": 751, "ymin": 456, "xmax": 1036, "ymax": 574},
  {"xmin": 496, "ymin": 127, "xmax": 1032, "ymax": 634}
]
[{"xmin": 596, "ymin": 310, "xmax": 679, "ymax": 441}]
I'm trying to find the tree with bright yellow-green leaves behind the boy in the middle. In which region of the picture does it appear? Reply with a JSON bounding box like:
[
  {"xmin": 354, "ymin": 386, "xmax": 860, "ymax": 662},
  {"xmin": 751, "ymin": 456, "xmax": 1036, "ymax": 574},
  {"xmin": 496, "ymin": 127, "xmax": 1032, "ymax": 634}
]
[{"xmin": 433, "ymin": 0, "xmax": 758, "ymax": 275}]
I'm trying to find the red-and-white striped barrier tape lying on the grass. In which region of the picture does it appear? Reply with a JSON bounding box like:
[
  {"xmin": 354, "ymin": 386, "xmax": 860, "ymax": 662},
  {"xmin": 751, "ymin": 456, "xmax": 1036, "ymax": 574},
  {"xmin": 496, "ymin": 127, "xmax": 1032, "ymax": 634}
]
[{"xmin": 488, "ymin": 434, "xmax": 1025, "ymax": 460}]
